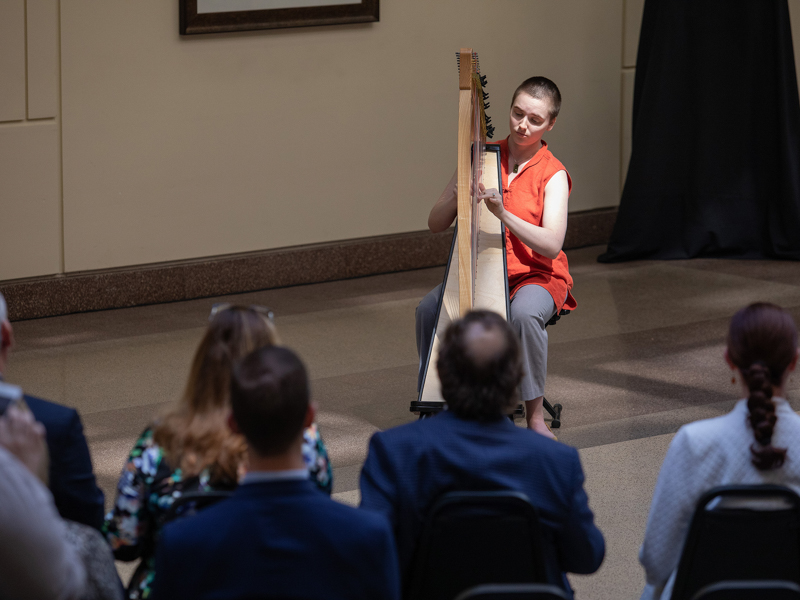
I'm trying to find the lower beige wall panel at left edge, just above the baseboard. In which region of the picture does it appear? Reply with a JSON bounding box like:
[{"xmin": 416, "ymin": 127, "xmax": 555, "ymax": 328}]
[{"xmin": 0, "ymin": 122, "xmax": 61, "ymax": 281}]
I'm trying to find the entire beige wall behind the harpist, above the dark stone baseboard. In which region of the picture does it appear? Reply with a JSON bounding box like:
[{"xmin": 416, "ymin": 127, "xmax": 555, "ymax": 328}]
[{"xmin": 0, "ymin": 0, "xmax": 800, "ymax": 280}]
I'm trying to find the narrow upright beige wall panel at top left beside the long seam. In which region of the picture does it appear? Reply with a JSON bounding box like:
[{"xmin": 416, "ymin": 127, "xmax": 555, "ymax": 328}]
[{"xmin": 26, "ymin": 0, "xmax": 58, "ymax": 119}]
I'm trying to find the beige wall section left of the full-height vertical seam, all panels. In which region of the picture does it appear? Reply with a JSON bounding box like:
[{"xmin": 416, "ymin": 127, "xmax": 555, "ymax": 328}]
[{"xmin": 0, "ymin": 0, "xmax": 63, "ymax": 280}]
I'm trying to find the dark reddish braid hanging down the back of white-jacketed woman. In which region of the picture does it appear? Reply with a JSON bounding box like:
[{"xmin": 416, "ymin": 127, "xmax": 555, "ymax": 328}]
[{"xmin": 742, "ymin": 361, "xmax": 786, "ymax": 471}]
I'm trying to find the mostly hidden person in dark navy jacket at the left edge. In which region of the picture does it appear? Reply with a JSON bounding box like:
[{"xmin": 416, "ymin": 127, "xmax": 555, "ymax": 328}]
[{"xmin": 0, "ymin": 294, "xmax": 103, "ymax": 530}]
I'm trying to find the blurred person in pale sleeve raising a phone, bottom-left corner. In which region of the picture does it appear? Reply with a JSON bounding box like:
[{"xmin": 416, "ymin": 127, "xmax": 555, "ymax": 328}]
[{"xmin": 0, "ymin": 406, "xmax": 86, "ymax": 600}]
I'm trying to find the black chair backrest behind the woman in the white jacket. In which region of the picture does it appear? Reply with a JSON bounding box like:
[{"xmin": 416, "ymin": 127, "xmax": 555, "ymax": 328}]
[{"xmin": 672, "ymin": 485, "xmax": 800, "ymax": 600}]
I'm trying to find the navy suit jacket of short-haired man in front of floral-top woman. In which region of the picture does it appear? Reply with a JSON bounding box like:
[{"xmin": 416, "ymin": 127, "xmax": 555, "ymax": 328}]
[{"xmin": 153, "ymin": 480, "xmax": 400, "ymax": 600}]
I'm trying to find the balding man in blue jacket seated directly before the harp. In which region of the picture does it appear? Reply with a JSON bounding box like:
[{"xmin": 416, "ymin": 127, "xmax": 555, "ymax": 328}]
[{"xmin": 361, "ymin": 311, "xmax": 605, "ymax": 591}]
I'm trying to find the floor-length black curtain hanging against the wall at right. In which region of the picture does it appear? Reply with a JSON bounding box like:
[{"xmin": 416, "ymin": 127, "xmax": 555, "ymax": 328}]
[{"xmin": 598, "ymin": 0, "xmax": 800, "ymax": 262}]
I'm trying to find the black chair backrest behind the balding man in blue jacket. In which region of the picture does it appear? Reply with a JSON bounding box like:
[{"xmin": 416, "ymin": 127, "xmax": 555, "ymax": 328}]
[{"xmin": 404, "ymin": 491, "xmax": 545, "ymax": 600}]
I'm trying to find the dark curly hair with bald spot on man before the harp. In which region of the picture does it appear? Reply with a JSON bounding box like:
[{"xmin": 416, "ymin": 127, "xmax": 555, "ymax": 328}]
[{"xmin": 436, "ymin": 310, "xmax": 522, "ymax": 421}]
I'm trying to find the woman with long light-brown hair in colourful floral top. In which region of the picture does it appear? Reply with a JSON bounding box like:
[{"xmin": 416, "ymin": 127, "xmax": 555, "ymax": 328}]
[{"xmin": 105, "ymin": 305, "xmax": 332, "ymax": 600}]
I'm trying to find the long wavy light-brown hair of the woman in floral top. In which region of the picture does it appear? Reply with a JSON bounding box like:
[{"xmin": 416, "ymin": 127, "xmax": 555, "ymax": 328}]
[{"xmin": 153, "ymin": 306, "xmax": 279, "ymax": 483}]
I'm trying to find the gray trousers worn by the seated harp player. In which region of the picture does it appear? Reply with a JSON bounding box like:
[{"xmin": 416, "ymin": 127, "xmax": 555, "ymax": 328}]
[{"xmin": 417, "ymin": 285, "xmax": 556, "ymax": 401}]
